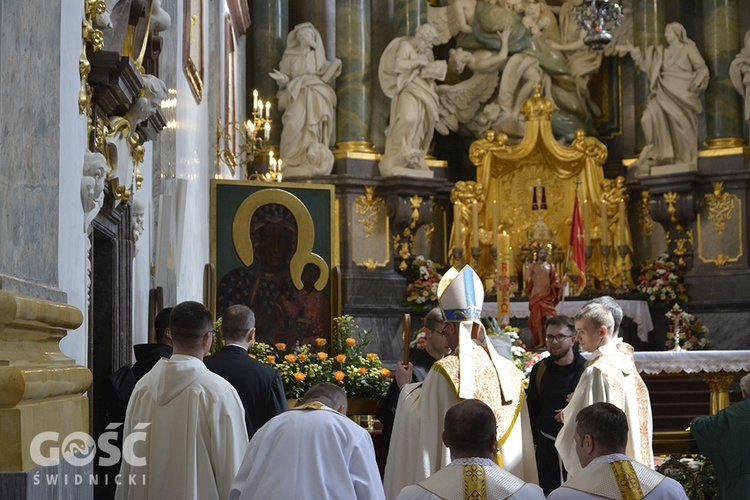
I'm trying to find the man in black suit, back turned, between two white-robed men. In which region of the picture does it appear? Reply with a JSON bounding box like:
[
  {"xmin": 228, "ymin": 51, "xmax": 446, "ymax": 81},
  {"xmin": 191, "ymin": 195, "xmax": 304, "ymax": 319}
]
[{"xmin": 204, "ymin": 304, "xmax": 287, "ymax": 439}]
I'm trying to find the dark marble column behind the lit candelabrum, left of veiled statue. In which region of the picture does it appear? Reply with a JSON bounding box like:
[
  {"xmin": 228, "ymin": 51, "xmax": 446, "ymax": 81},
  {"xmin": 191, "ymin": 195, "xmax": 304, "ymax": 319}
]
[{"xmin": 247, "ymin": 0, "xmax": 289, "ymax": 145}]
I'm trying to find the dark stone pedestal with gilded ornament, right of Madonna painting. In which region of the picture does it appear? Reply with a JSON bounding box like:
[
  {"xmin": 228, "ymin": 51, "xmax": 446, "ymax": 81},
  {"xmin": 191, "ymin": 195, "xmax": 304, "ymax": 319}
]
[{"xmin": 327, "ymin": 152, "xmax": 452, "ymax": 366}]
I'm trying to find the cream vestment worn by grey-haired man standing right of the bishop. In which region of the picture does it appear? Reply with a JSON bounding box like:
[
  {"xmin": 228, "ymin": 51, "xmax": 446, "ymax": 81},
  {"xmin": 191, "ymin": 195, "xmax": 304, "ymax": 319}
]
[{"xmin": 555, "ymin": 342, "xmax": 654, "ymax": 478}]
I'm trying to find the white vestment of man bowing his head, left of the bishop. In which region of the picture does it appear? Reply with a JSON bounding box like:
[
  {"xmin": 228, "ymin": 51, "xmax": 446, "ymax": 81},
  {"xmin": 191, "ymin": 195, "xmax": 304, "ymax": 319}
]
[{"xmin": 229, "ymin": 401, "xmax": 384, "ymax": 500}]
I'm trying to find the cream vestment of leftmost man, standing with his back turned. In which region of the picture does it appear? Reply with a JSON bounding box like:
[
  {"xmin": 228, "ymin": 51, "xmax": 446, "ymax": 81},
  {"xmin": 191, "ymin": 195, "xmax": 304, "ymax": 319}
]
[{"xmin": 115, "ymin": 354, "xmax": 248, "ymax": 500}]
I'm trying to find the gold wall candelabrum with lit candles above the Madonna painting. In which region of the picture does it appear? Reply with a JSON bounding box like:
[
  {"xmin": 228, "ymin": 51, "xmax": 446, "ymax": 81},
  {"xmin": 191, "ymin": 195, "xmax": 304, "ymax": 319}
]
[{"xmin": 216, "ymin": 90, "xmax": 281, "ymax": 181}]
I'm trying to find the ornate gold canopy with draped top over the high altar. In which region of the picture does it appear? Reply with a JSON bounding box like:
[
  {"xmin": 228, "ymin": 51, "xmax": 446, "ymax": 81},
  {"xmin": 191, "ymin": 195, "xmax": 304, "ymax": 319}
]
[{"xmin": 458, "ymin": 86, "xmax": 632, "ymax": 288}]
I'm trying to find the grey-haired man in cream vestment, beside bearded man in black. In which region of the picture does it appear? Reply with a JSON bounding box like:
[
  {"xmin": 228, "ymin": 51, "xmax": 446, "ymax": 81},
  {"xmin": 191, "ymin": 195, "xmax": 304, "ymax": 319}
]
[{"xmin": 555, "ymin": 303, "xmax": 654, "ymax": 478}]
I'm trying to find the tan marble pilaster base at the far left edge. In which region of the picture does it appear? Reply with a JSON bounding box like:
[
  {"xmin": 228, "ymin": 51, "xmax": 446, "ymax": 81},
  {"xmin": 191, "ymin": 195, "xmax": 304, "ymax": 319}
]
[{"xmin": 0, "ymin": 290, "xmax": 93, "ymax": 498}]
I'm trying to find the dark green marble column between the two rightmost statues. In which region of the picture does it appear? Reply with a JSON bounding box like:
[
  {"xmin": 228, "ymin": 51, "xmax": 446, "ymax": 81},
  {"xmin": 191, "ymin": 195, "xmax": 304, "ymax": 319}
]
[{"xmin": 703, "ymin": 0, "xmax": 743, "ymax": 149}]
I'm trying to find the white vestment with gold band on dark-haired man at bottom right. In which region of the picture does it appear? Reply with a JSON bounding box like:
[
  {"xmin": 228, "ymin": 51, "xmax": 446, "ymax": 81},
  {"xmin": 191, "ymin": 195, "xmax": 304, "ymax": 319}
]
[{"xmin": 547, "ymin": 453, "xmax": 687, "ymax": 500}]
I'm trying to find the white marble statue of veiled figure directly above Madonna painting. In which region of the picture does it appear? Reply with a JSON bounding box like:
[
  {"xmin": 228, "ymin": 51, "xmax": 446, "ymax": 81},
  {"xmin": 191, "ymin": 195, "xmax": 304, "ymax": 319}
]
[{"xmin": 270, "ymin": 23, "xmax": 341, "ymax": 177}]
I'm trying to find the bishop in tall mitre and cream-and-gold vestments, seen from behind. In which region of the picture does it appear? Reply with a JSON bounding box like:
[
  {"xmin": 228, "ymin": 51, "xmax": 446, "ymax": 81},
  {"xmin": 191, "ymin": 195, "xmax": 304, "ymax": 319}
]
[{"xmin": 384, "ymin": 266, "xmax": 537, "ymax": 499}]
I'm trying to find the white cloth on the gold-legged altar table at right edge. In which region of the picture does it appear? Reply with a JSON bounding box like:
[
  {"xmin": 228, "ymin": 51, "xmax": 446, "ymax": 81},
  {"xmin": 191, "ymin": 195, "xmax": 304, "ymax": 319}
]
[{"xmin": 633, "ymin": 350, "xmax": 750, "ymax": 375}]
